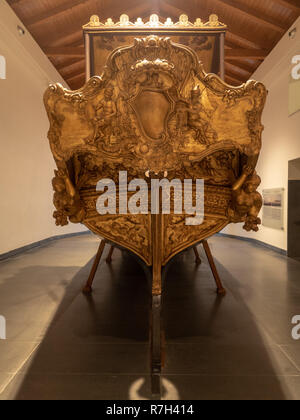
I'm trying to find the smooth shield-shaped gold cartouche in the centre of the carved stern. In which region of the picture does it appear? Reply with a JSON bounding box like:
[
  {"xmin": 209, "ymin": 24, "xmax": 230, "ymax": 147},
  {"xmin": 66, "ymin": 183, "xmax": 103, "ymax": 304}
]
[{"xmin": 132, "ymin": 90, "xmax": 171, "ymax": 140}]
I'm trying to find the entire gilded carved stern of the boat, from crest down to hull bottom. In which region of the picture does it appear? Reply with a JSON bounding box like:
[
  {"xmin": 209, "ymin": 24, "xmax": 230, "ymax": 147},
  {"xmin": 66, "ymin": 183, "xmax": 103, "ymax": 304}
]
[{"xmin": 44, "ymin": 35, "xmax": 266, "ymax": 265}]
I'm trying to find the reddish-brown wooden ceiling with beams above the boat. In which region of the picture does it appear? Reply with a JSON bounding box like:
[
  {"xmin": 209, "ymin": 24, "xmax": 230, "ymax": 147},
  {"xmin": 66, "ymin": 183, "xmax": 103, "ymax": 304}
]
[{"xmin": 7, "ymin": 0, "xmax": 300, "ymax": 89}]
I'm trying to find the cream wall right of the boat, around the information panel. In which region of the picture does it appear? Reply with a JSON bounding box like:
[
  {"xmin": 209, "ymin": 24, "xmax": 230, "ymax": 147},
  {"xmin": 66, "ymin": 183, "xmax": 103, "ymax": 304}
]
[{"xmin": 224, "ymin": 18, "xmax": 300, "ymax": 250}]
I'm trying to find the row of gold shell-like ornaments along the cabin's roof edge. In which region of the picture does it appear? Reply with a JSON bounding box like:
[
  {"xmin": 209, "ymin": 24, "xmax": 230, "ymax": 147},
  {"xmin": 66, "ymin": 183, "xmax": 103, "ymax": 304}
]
[{"xmin": 83, "ymin": 14, "xmax": 227, "ymax": 30}]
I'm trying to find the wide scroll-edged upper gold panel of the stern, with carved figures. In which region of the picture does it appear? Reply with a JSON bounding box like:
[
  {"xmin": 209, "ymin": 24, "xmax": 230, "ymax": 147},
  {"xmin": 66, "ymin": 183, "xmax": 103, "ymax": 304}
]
[{"xmin": 45, "ymin": 36, "xmax": 266, "ymax": 172}]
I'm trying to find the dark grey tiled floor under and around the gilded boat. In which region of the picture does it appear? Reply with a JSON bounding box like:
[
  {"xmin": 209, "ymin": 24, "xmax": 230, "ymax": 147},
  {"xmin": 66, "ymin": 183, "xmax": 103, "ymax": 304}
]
[{"xmin": 0, "ymin": 235, "xmax": 300, "ymax": 400}]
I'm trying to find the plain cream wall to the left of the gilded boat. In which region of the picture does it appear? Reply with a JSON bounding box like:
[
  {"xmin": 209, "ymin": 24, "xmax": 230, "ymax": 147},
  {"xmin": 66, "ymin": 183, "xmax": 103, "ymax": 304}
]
[{"xmin": 0, "ymin": 0, "xmax": 85, "ymax": 254}]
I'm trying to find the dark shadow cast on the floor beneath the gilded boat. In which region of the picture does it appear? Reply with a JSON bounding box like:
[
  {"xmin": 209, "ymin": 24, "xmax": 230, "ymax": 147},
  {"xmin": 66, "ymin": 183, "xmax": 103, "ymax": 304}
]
[{"xmin": 1, "ymin": 243, "xmax": 295, "ymax": 400}]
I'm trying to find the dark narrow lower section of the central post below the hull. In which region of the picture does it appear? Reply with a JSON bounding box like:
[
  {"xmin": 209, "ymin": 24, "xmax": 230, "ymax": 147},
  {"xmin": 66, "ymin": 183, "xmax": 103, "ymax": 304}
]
[{"xmin": 151, "ymin": 295, "xmax": 161, "ymax": 399}]
